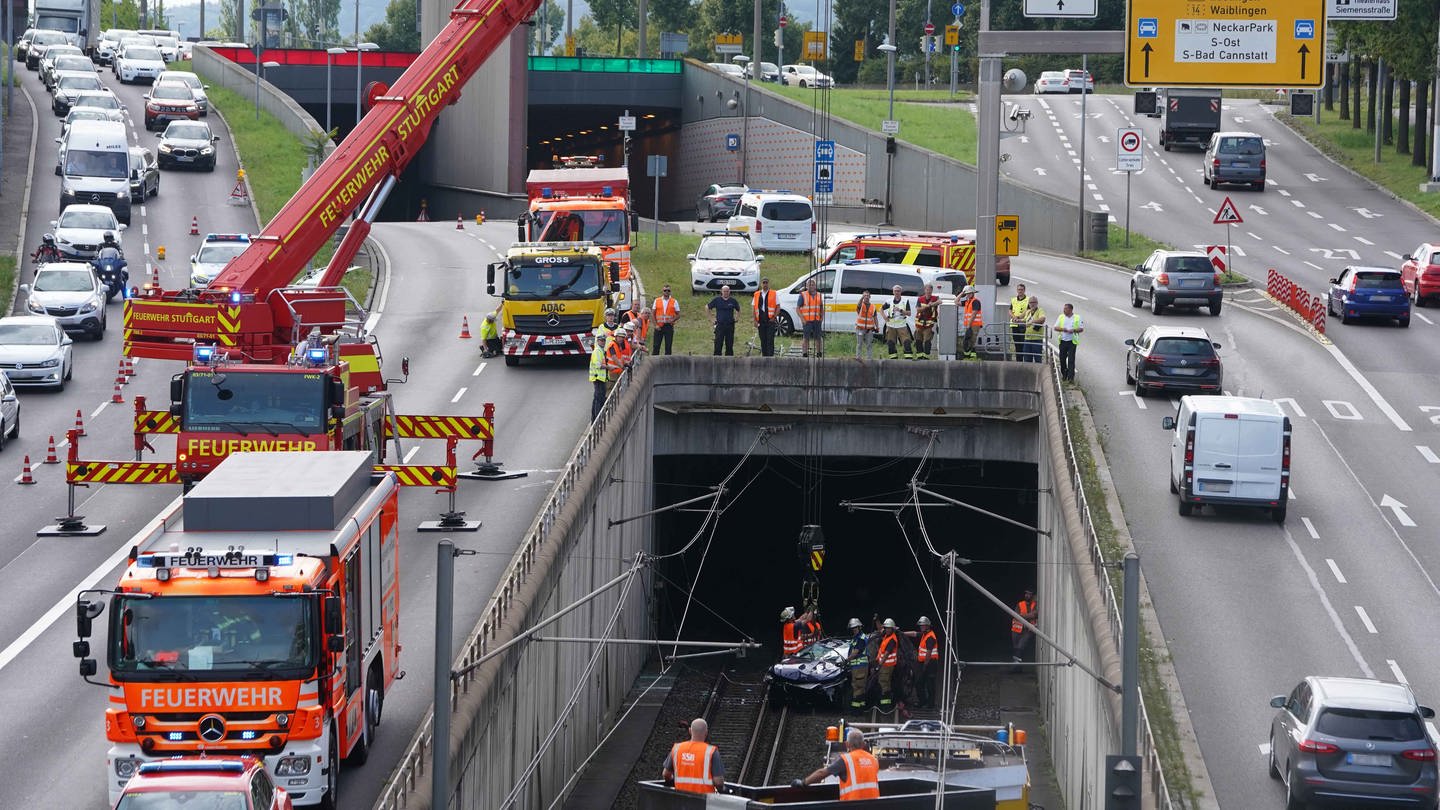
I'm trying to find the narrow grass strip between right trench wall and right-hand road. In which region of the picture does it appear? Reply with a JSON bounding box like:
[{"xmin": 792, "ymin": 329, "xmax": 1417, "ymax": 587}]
[{"xmin": 1067, "ymin": 405, "xmax": 1200, "ymax": 806}]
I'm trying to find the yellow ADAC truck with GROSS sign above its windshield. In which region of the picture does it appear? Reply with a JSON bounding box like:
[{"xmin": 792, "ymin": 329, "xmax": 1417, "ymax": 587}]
[{"xmin": 485, "ymin": 242, "xmax": 619, "ymax": 366}]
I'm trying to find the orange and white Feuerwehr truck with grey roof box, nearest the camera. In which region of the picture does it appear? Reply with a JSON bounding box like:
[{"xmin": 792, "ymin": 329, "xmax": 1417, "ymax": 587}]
[{"xmin": 73, "ymin": 451, "xmax": 403, "ymax": 807}]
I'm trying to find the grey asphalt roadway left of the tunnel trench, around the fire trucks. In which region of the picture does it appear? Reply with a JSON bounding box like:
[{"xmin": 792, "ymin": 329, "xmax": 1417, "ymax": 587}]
[{"xmin": 0, "ymin": 53, "xmax": 590, "ymax": 809}]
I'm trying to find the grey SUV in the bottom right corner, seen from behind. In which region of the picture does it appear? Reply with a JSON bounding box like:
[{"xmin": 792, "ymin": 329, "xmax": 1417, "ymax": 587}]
[{"xmin": 1270, "ymin": 676, "xmax": 1440, "ymax": 810}]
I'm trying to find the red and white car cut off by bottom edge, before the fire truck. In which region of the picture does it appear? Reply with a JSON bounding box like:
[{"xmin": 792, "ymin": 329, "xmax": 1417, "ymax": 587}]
[{"xmin": 115, "ymin": 757, "xmax": 292, "ymax": 810}]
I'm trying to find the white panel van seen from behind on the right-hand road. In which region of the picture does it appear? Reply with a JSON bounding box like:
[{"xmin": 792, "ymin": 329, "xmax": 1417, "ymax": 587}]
[{"xmin": 1161, "ymin": 396, "xmax": 1290, "ymax": 523}]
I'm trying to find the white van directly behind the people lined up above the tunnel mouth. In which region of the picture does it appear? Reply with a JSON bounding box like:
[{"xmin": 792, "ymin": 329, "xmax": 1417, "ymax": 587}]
[{"xmin": 776, "ymin": 259, "xmax": 965, "ymax": 334}]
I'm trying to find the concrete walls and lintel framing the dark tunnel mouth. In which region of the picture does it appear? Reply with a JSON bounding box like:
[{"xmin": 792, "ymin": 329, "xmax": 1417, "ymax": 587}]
[{"xmin": 376, "ymin": 357, "xmax": 1153, "ymax": 810}]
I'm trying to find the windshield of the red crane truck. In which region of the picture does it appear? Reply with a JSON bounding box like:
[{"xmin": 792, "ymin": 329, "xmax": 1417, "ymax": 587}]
[{"xmin": 184, "ymin": 369, "xmax": 325, "ymax": 434}]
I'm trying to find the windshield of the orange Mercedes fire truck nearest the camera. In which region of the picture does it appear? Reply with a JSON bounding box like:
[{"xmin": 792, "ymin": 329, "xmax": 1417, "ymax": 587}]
[{"xmin": 108, "ymin": 595, "xmax": 317, "ymax": 680}]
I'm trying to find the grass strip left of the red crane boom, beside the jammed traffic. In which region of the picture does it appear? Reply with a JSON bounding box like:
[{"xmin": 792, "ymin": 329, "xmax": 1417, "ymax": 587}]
[{"xmin": 188, "ymin": 62, "xmax": 374, "ymax": 304}]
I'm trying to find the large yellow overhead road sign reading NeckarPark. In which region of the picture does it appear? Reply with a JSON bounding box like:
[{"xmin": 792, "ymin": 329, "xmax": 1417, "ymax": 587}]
[{"xmin": 1125, "ymin": 0, "xmax": 1328, "ymax": 88}]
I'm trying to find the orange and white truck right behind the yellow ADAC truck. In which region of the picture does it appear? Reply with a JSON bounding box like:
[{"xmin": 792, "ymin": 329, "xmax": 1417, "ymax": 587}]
[{"xmin": 516, "ymin": 167, "xmax": 639, "ymax": 310}]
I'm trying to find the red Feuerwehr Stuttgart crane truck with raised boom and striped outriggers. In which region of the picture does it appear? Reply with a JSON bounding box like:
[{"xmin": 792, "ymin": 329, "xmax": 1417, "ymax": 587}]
[{"xmin": 95, "ymin": 0, "xmax": 561, "ymax": 484}]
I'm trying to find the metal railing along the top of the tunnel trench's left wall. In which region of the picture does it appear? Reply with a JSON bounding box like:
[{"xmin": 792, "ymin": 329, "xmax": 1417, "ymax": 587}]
[{"xmin": 374, "ymin": 352, "xmax": 645, "ymax": 810}]
